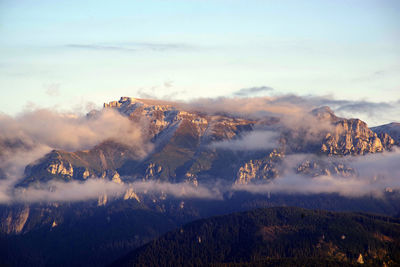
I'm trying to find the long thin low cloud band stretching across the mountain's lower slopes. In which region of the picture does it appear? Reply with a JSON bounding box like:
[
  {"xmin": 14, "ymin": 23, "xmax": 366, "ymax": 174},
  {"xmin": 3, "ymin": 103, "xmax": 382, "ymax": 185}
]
[{"xmin": 0, "ymin": 150, "xmax": 400, "ymax": 203}]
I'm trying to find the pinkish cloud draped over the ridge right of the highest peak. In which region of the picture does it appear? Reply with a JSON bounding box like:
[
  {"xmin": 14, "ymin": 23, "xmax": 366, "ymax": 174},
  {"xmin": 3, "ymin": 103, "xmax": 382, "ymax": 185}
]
[{"xmin": 177, "ymin": 95, "xmax": 334, "ymax": 150}]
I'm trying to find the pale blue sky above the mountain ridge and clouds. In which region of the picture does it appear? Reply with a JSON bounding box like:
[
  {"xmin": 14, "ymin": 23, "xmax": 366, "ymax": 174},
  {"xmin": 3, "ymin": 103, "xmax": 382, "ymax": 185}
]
[{"xmin": 0, "ymin": 0, "xmax": 400, "ymax": 120}]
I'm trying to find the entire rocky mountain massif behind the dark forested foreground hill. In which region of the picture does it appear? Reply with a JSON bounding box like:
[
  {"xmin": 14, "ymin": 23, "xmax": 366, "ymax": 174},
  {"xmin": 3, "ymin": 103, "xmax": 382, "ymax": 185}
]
[{"xmin": 0, "ymin": 97, "xmax": 400, "ymax": 266}]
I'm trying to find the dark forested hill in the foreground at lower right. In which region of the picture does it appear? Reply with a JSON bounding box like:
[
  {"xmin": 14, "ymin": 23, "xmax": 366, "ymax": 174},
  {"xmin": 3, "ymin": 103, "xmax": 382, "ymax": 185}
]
[{"xmin": 112, "ymin": 208, "xmax": 400, "ymax": 266}]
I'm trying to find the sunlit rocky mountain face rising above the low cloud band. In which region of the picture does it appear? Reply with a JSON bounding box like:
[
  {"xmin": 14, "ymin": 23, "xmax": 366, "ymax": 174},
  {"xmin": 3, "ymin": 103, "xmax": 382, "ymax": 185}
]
[{"xmin": 19, "ymin": 97, "xmax": 395, "ymax": 186}]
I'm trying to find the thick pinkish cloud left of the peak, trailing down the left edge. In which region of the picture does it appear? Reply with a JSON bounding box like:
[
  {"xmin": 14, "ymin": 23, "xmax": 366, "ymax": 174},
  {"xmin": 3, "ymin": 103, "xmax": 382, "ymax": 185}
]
[{"xmin": 0, "ymin": 109, "xmax": 153, "ymax": 201}]
